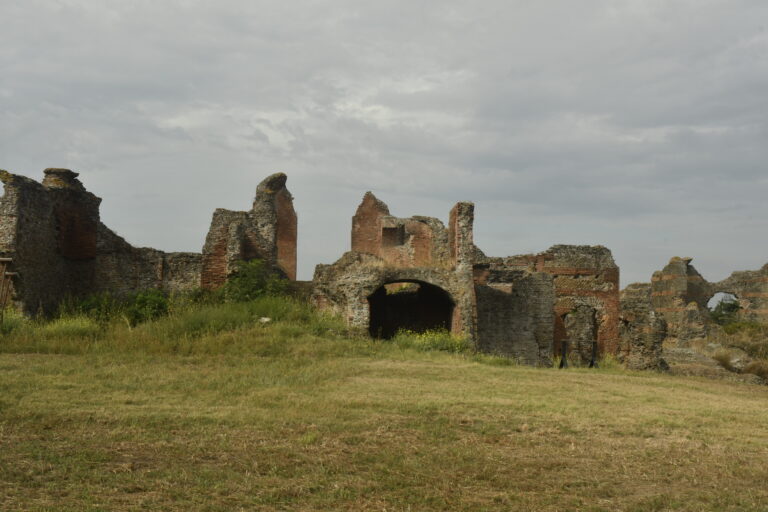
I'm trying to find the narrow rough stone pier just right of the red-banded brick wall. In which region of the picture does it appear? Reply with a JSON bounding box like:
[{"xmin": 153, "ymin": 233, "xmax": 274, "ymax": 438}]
[{"xmin": 618, "ymin": 283, "xmax": 668, "ymax": 370}]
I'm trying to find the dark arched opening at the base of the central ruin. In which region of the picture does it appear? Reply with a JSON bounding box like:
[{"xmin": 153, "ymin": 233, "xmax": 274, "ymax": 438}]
[{"xmin": 368, "ymin": 281, "xmax": 454, "ymax": 339}]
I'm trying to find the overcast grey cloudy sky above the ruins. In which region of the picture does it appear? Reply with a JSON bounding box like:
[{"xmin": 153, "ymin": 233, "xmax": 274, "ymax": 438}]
[{"xmin": 0, "ymin": 0, "xmax": 768, "ymax": 285}]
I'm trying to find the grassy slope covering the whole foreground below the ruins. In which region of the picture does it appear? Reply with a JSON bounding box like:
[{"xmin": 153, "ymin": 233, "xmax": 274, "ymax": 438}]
[{"xmin": 0, "ymin": 298, "xmax": 768, "ymax": 512}]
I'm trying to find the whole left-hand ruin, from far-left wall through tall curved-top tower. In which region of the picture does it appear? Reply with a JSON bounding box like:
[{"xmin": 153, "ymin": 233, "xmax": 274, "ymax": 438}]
[{"xmin": 0, "ymin": 169, "xmax": 296, "ymax": 315}]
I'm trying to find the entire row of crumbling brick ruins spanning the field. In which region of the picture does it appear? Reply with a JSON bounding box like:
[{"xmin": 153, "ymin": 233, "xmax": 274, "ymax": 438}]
[{"xmin": 0, "ymin": 169, "xmax": 768, "ymax": 369}]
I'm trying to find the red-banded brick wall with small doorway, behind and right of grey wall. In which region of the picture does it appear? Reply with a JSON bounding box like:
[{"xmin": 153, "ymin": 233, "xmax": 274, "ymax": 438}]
[{"xmin": 476, "ymin": 245, "xmax": 619, "ymax": 362}]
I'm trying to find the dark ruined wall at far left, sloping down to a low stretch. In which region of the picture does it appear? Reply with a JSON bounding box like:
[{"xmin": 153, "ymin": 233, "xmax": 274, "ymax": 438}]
[{"xmin": 0, "ymin": 169, "xmax": 201, "ymax": 314}]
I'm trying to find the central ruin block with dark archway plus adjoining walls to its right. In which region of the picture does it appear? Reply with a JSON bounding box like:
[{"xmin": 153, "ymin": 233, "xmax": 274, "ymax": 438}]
[{"xmin": 313, "ymin": 192, "xmax": 619, "ymax": 365}]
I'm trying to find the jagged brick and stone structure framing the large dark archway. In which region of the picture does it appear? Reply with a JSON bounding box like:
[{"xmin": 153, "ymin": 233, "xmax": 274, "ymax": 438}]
[{"xmin": 313, "ymin": 192, "xmax": 475, "ymax": 339}]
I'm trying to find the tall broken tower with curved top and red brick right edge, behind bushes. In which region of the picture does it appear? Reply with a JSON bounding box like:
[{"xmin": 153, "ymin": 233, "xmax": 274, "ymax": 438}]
[{"xmin": 201, "ymin": 173, "xmax": 297, "ymax": 288}]
